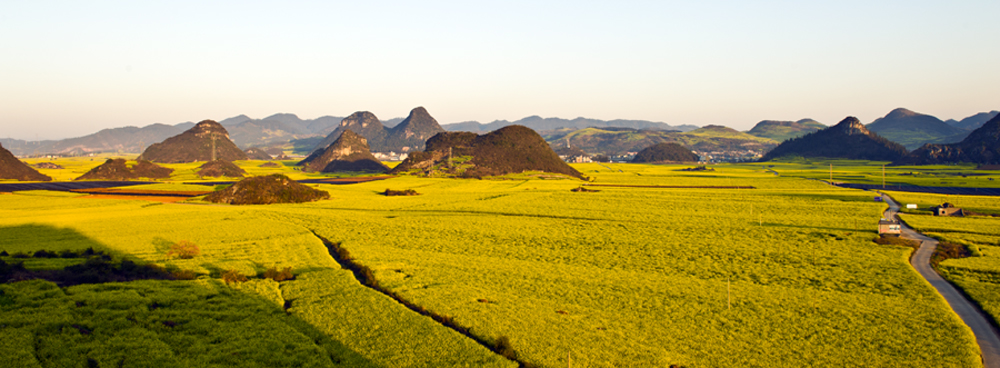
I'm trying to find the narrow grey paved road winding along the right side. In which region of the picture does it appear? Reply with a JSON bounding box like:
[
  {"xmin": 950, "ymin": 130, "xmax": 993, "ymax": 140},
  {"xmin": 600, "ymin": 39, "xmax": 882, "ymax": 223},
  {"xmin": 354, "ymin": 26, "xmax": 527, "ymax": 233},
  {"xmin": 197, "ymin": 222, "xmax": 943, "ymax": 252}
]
[{"xmin": 883, "ymin": 196, "xmax": 1000, "ymax": 368}]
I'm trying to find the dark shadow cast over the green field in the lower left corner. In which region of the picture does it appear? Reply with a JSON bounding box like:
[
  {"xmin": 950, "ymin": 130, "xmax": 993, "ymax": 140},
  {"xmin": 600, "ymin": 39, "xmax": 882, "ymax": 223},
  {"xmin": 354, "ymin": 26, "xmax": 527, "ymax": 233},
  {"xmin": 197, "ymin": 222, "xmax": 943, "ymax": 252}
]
[{"xmin": 0, "ymin": 224, "xmax": 379, "ymax": 367}]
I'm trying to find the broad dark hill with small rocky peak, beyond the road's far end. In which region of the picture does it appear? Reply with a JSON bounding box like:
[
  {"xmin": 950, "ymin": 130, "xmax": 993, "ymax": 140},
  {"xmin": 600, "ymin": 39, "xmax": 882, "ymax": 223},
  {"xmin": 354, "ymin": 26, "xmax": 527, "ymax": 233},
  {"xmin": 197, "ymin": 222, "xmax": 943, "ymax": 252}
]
[{"xmin": 761, "ymin": 116, "xmax": 906, "ymax": 161}]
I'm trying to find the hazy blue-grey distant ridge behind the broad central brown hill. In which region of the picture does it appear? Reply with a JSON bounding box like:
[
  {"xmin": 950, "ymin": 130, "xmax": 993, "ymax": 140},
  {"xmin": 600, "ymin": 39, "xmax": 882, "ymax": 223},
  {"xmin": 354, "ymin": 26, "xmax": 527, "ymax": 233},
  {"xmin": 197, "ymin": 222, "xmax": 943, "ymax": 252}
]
[{"xmin": 441, "ymin": 115, "xmax": 698, "ymax": 132}]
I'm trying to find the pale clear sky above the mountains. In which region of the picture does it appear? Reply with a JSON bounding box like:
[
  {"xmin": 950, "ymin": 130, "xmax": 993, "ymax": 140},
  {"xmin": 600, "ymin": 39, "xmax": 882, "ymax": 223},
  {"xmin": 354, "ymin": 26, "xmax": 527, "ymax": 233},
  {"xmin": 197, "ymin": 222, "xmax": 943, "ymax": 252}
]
[{"xmin": 0, "ymin": 0, "xmax": 1000, "ymax": 140}]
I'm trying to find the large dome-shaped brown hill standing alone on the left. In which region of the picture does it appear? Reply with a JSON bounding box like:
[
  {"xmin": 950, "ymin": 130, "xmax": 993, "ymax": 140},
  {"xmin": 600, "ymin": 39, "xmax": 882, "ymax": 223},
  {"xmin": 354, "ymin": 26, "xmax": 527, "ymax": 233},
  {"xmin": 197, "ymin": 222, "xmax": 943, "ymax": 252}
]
[{"xmin": 138, "ymin": 120, "xmax": 247, "ymax": 164}]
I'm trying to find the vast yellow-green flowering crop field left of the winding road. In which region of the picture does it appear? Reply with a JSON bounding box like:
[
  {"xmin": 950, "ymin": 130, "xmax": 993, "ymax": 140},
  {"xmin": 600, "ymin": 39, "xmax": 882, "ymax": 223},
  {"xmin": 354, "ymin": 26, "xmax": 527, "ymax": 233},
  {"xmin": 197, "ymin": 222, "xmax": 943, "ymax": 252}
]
[{"xmin": 0, "ymin": 164, "xmax": 988, "ymax": 367}]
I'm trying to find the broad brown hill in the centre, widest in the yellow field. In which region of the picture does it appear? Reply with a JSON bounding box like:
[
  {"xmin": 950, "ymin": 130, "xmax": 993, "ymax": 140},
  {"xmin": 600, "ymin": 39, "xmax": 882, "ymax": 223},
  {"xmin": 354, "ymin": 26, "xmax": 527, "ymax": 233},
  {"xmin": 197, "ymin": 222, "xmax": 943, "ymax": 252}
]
[{"xmin": 390, "ymin": 125, "xmax": 583, "ymax": 178}]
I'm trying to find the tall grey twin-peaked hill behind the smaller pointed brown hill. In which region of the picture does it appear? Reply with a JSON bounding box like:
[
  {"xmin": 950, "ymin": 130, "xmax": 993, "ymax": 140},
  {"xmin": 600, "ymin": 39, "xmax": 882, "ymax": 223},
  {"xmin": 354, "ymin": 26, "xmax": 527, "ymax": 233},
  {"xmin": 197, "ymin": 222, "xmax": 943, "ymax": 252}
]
[{"xmin": 313, "ymin": 107, "xmax": 444, "ymax": 152}]
